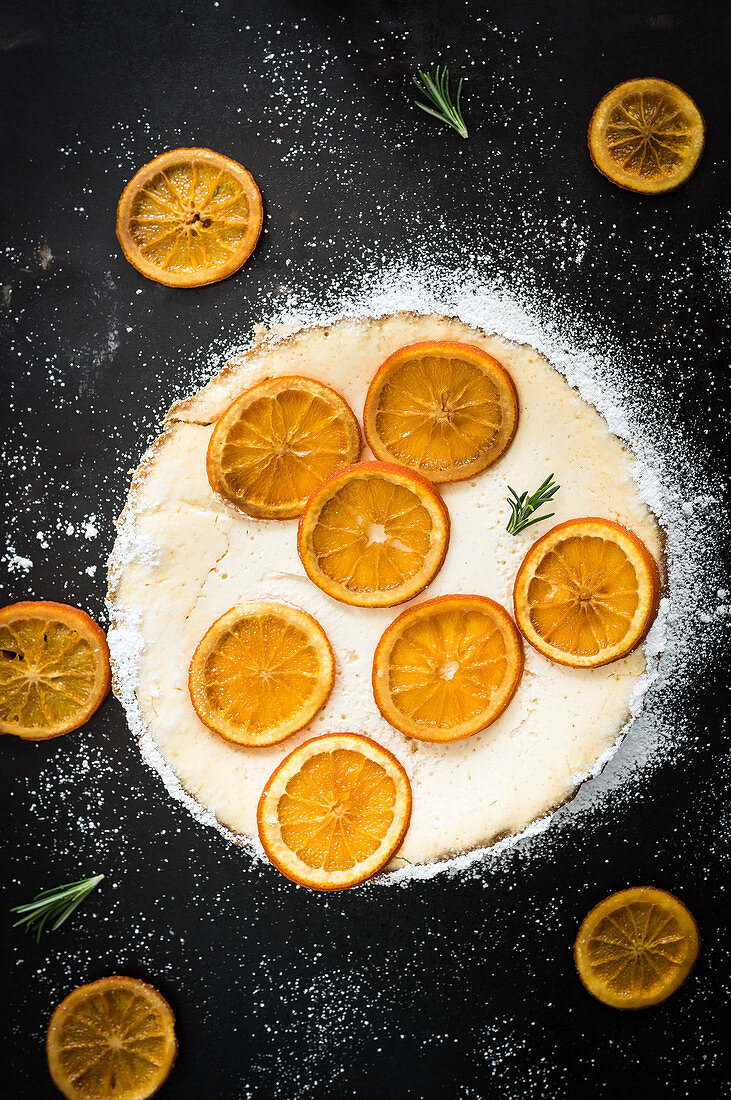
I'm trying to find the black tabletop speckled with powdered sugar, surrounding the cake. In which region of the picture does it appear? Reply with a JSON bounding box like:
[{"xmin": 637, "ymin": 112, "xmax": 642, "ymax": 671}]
[{"xmin": 0, "ymin": 0, "xmax": 731, "ymax": 1100}]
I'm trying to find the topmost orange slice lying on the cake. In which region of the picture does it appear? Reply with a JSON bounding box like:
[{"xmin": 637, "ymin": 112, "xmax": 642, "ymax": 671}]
[{"xmin": 363, "ymin": 340, "xmax": 518, "ymax": 482}]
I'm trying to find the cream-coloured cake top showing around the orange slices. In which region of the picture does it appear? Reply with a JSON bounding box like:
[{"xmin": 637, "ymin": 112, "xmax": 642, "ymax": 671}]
[{"xmin": 110, "ymin": 314, "xmax": 663, "ymax": 868}]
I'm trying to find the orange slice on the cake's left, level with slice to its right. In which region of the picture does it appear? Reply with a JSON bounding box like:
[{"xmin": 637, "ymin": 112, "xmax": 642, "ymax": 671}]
[{"xmin": 188, "ymin": 600, "xmax": 335, "ymax": 746}]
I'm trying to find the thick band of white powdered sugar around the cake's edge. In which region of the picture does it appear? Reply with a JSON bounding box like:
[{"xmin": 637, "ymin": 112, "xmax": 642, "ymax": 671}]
[{"xmin": 103, "ymin": 255, "xmax": 728, "ymax": 884}]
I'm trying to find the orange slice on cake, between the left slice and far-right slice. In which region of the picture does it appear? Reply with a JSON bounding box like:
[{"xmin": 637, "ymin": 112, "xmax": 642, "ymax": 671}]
[{"xmin": 373, "ymin": 595, "xmax": 523, "ymax": 741}]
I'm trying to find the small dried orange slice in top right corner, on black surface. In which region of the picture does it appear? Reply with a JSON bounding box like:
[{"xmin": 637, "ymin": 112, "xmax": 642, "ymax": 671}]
[{"xmin": 588, "ymin": 78, "xmax": 706, "ymax": 195}]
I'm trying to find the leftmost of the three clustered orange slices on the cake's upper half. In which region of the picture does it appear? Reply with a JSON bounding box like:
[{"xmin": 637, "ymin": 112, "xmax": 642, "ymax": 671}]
[{"xmin": 207, "ymin": 377, "xmax": 361, "ymax": 519}]
